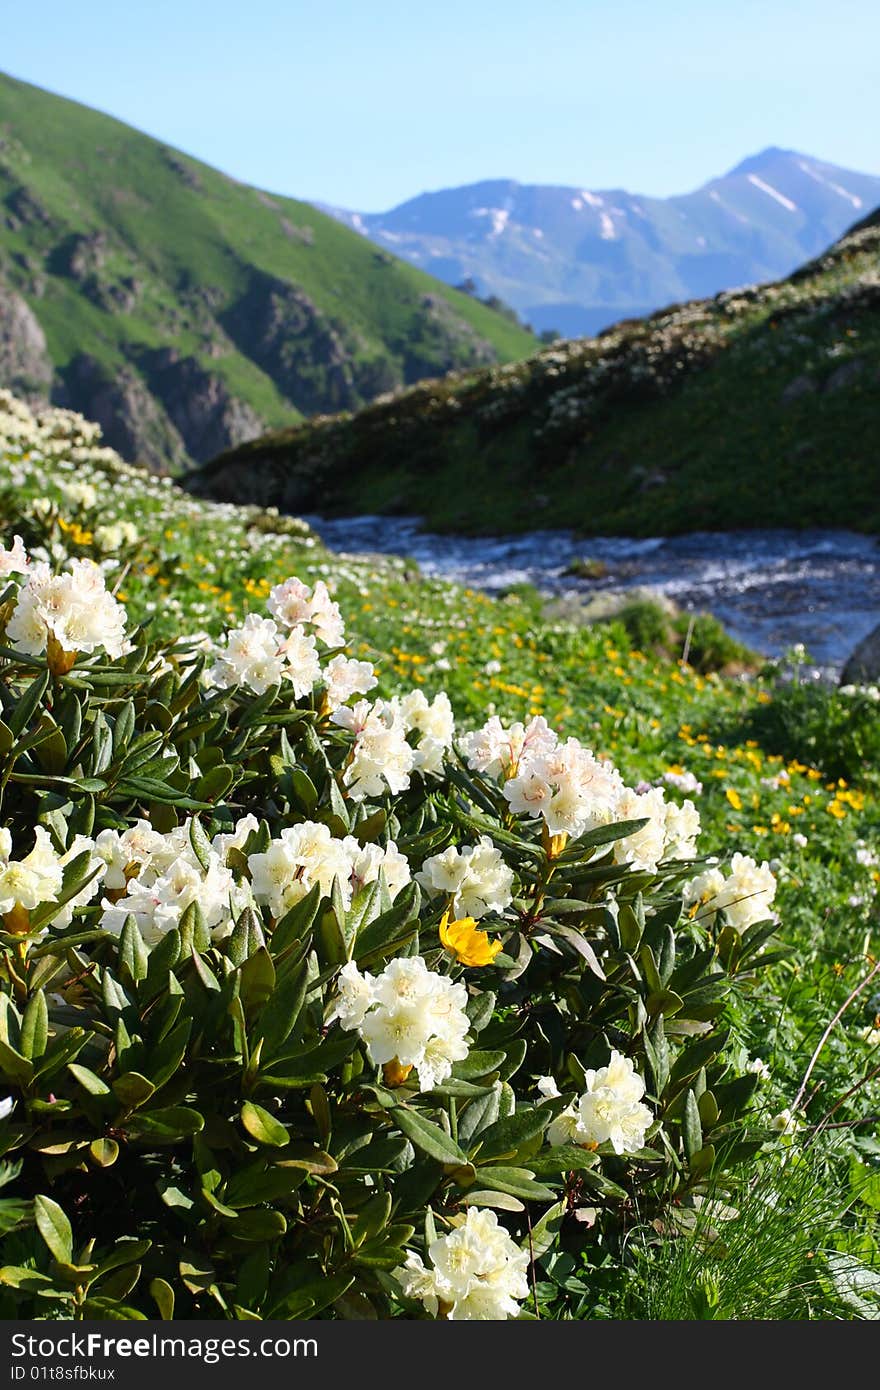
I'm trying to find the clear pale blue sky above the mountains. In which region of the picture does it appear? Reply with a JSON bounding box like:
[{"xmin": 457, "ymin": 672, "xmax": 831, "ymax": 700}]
[{"xmin": 0, "ymin": 0, "xmax": 880, "ymax": 211}]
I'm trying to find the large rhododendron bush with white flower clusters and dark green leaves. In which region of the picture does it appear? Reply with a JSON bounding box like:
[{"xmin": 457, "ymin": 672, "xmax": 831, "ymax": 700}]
[{"xmin": 0, "ymin": 525, "xmax": 776, "ymax": 1319}]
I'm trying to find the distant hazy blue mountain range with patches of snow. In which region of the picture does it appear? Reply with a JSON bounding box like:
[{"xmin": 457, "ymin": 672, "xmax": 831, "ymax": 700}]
[{"xmin": 327, "ymin": 147, "xmax": 880, "ymax": 338}]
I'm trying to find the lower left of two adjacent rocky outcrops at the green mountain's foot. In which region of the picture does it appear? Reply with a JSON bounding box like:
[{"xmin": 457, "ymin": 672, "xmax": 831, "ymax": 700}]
[{"xmin": 56, "ymin": 353, "xmax": 189, "ymax": 473}]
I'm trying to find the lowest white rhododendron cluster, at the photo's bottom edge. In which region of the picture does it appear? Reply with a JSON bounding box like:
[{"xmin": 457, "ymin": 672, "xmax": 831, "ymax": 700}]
[{"xmin": 393, "ymin": 1207, "xmax": 528, "ymax": 1322}]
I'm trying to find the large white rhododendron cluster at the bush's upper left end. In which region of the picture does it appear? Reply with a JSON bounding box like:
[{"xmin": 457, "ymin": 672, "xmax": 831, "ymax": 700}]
[{"xmin": 6, "ymin": 560, "xmax": 131, "ymax": 657}]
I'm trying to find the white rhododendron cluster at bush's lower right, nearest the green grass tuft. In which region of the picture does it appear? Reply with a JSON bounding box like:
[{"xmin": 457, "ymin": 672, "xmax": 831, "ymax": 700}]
[{"xmin": 546, "ymin": 1052, "xmax": 653, "ymax": 1154}]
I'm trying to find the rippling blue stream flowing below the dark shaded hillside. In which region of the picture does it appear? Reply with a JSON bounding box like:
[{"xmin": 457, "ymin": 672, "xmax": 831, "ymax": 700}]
[{"xmin": 307, "ymin": 516, "xmax": 880, "ymax": 674}]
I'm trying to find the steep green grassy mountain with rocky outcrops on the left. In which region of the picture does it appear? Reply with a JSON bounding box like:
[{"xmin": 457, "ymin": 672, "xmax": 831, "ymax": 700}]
[{"xmin": 0, "ymin": 75, "xmax": 535, "ymax": 468}]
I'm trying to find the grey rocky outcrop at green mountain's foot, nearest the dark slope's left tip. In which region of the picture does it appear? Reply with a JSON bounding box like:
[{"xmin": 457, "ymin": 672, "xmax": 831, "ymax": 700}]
[{"xmin": 140, "ymin": 348, "xmax": 264, "ymax": 461}]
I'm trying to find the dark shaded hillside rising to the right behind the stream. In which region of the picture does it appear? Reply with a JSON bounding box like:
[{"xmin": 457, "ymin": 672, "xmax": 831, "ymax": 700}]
[{"xmin": 192, "ymin": 213, "xmax": 880, "ymax": 535}]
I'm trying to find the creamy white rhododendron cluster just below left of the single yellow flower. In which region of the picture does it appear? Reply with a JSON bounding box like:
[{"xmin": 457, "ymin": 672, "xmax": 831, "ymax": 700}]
[{"xmin": 328, "ymin": 956, "xmax": 470, "ymax": 1091}]
